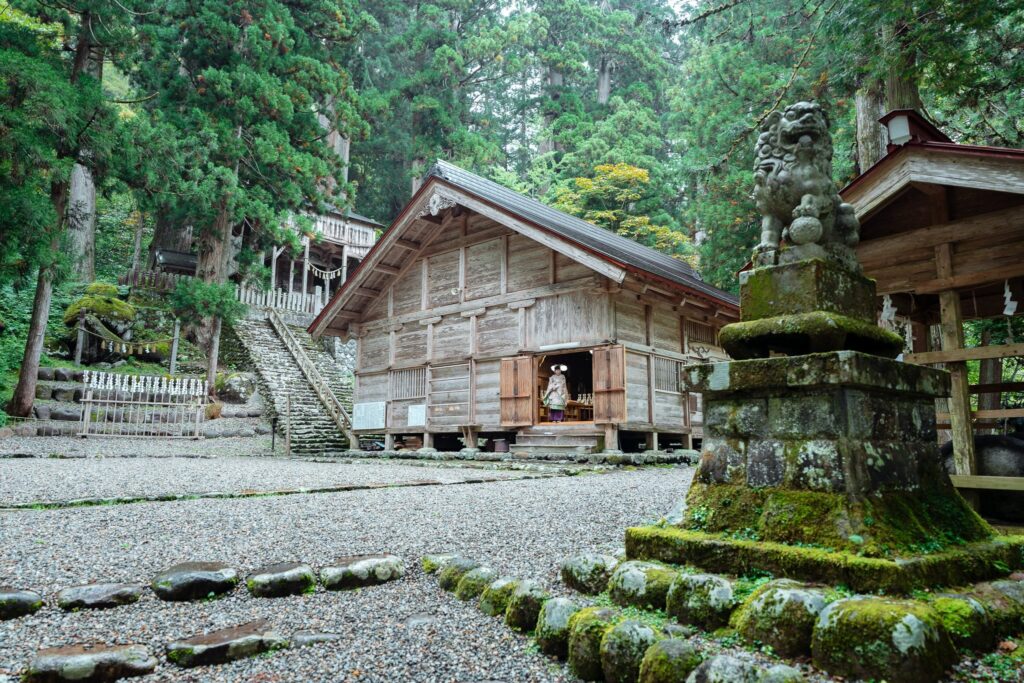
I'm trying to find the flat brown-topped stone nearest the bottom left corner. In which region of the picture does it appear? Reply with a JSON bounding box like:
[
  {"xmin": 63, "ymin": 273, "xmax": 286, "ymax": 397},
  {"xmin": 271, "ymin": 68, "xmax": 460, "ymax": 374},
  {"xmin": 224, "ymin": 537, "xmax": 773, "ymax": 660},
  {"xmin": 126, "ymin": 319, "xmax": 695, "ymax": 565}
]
[{"xmin": 22, "ymin": 644, "xmax": 157, "ymax": 683}]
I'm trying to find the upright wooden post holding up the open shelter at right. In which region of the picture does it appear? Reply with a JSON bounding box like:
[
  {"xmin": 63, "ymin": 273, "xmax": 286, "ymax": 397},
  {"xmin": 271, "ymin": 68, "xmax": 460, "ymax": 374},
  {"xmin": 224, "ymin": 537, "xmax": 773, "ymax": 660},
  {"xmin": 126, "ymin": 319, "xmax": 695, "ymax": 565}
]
[{"xmin": 935, "ymin": 244, "xmax": 978, "ymax": 489}]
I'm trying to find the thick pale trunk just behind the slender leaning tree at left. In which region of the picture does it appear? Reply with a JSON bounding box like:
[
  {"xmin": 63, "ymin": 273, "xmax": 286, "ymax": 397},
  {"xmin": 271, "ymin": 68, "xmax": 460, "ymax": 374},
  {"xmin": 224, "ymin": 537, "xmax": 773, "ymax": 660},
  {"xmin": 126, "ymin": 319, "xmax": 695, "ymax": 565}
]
[{"xmin": 67, "ymin": 48, "xmax": 103, "ymax": 283}]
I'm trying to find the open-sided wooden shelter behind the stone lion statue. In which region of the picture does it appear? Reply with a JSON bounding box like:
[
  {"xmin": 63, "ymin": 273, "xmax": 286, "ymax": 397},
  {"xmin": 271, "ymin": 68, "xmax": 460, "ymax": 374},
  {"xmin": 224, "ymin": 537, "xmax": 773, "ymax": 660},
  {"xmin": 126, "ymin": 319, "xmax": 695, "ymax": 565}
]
[{"xmin": 841, "ymin": 110, "xmax": 1024, "ymax": 499}]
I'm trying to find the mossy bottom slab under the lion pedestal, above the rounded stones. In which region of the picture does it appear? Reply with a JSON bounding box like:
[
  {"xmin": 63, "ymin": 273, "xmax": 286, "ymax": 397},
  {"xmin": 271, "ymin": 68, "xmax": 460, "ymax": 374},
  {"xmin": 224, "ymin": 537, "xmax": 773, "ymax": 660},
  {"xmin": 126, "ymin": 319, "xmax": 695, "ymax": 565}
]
[{"xmin": 626, "ymin": 526, "xmax": 1024, "ymax": 594}]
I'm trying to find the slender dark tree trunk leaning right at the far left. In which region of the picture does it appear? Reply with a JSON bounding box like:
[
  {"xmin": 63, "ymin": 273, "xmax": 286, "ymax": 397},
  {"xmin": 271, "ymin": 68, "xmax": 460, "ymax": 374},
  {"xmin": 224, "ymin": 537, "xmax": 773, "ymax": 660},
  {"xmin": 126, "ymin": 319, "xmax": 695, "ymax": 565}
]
[{"xmin": 7, "ymin": 179, "xmax": 69, "ymax": 418}]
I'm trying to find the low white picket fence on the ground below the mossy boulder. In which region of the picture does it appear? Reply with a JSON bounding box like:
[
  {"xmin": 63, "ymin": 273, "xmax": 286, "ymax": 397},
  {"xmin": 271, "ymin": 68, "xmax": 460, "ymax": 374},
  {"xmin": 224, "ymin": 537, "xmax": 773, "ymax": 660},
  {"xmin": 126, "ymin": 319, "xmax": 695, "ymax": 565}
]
[{"xmin": 79, "ymin": 371, "xmax": 209, "ymax": 438}]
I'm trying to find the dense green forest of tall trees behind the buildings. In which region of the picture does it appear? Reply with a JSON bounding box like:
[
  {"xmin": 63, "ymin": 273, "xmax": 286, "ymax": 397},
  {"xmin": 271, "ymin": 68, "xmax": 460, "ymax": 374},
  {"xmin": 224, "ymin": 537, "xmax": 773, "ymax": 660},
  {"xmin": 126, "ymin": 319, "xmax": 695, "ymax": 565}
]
[{"xmin": 0, "ymin": 0, "xmax": 1024, "ymax": 420}]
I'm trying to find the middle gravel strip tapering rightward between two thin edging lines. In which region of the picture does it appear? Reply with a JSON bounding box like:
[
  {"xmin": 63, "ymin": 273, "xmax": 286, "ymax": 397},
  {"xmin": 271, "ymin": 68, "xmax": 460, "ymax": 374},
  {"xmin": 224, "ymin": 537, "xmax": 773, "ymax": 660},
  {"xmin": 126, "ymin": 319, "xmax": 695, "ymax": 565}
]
[{"xmin": 0, "ymin": 456, "xmax": 536, "ymax": 506}]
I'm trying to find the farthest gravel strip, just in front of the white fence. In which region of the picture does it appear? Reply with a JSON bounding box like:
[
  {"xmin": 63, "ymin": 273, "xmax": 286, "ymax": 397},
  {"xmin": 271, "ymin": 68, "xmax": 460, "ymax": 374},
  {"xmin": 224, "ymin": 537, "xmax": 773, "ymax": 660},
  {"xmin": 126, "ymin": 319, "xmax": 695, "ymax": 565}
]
[{"xmin": 0, "ymin": 436, "xmax": 276, "ymax": 460}]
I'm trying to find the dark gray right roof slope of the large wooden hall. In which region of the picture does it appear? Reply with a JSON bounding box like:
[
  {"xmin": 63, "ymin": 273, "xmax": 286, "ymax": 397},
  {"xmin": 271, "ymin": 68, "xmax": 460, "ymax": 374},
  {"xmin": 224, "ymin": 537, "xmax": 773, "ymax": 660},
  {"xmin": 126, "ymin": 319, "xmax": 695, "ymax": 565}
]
[{"xmin": 427, "ymin": 160, "xmax": 738, "ymax": 304}]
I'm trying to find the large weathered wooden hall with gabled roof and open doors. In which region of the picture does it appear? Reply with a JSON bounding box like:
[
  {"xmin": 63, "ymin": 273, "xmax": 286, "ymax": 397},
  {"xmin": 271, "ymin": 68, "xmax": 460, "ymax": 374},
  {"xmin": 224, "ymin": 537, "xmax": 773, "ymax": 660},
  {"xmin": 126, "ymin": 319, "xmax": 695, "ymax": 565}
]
[{"xmin": 309, "ymin": 162, "xmax": 738, "ymax": 451}]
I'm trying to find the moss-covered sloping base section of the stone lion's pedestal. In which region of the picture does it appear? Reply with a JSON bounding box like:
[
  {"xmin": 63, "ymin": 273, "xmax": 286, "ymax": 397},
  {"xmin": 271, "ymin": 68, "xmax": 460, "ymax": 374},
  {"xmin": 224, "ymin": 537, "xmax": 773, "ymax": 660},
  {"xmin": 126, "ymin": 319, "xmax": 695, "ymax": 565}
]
[{"xmin": 681, "ymin": 482, "xmax": 993, "ymax": 558}]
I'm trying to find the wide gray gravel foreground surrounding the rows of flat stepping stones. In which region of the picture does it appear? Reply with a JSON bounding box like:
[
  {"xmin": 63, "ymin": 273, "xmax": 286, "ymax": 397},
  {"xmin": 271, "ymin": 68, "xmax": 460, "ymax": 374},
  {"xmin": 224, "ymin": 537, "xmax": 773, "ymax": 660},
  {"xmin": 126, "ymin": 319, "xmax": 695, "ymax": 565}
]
[{"xmin": 0, "ymin": 461, "xmax": 692, "ymax": 683}]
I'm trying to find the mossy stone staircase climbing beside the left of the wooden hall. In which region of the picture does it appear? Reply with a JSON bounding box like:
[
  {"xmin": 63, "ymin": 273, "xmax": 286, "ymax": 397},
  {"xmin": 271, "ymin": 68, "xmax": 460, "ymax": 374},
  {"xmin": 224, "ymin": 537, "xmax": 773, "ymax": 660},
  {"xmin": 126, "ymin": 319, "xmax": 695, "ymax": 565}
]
[{"xmin": 234, "ymin": 319, "xmax": 352, "ymax": 455}]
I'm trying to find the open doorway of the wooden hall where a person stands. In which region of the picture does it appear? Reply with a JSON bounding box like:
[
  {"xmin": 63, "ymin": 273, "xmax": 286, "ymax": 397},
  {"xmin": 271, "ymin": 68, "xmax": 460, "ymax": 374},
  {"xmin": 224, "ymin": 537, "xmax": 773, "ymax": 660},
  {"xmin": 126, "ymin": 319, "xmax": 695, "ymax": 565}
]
[{"xmin": 536, "ymin": 351, "xmax": 594, "ymax": 424}]
